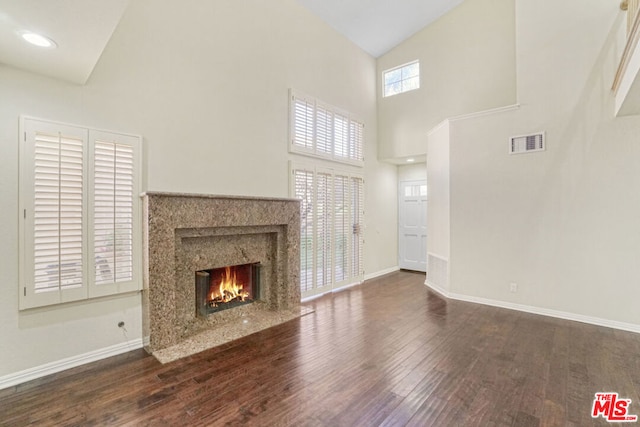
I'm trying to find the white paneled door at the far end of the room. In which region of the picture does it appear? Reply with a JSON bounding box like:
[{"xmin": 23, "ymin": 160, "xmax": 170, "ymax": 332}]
[{"xmin": 398, "ymin": 181, "xmax": 427, "ymax": 272}]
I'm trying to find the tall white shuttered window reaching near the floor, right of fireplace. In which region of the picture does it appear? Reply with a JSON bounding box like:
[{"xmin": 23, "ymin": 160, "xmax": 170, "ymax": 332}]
[{"xmin": 291, "ymin": 164, "xmax": 364, "ymax": 297}]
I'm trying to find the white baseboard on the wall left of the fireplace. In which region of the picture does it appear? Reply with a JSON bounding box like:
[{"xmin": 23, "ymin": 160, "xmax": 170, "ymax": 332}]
[{"xmin": 0, "ymin": 338, "xmax": 142, "ymax": 390}]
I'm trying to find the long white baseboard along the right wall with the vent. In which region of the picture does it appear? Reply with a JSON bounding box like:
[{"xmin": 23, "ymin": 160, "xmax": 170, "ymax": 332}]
[{"xmin": 425, "ymin": 281, "xmax": 640, "ymax": 333}]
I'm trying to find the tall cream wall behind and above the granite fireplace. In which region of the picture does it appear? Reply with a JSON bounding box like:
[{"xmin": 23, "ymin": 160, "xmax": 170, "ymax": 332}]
[{"xmin": 0, "ymin": 0, "xmax": 397, "ymax": 379}]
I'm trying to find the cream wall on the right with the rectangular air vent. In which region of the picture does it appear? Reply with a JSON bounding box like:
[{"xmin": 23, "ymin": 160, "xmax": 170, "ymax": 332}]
[{"xmin": 442, "ymin": 0, "xmax": 640, "ymax": 330}]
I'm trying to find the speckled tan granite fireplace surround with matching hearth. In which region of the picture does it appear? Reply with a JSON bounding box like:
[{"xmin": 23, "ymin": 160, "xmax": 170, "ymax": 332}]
[{"xmin": 142, "ymin": 193, "xmax": 305, "ymax": 363}]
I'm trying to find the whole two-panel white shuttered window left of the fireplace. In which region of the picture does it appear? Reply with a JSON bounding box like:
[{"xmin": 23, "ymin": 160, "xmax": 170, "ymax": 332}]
[{"xmin": 20, "ymin": 118, "xmax": 141, "ymax": 309}]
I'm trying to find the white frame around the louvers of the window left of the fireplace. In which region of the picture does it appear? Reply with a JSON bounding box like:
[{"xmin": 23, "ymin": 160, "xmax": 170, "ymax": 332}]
[{"xmin": 18, "ymin": 115, "xmax": 142, "ymax": 310}]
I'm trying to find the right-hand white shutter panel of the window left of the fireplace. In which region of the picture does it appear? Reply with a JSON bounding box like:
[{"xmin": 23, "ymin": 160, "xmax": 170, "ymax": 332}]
[{"xmin": 90, "ymin": 131, "xmax": 138, "ymax": 295}]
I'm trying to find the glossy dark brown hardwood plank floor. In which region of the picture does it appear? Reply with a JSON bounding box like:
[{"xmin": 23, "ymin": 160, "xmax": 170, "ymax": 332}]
[{"xmin": 0, "ymin": 272, "xmax": 640, "ymax": 427}]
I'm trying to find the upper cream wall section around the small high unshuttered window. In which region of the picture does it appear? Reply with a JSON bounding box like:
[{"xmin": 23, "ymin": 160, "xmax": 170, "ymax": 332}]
[{"xmin": 378, "ymin": 0, "xmax": 516, "ymax": 159}]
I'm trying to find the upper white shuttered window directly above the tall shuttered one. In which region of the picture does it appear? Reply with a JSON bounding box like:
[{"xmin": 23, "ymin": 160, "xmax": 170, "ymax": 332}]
[{"xmin": 289, "ymin": 91, "xmax": 364, "ymax": 166}]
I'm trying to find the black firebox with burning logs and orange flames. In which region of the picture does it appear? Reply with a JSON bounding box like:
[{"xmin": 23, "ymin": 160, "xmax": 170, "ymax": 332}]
[{"xmin": 196, "ymin": 263, "xmax": 260, "ymax": 317}]
